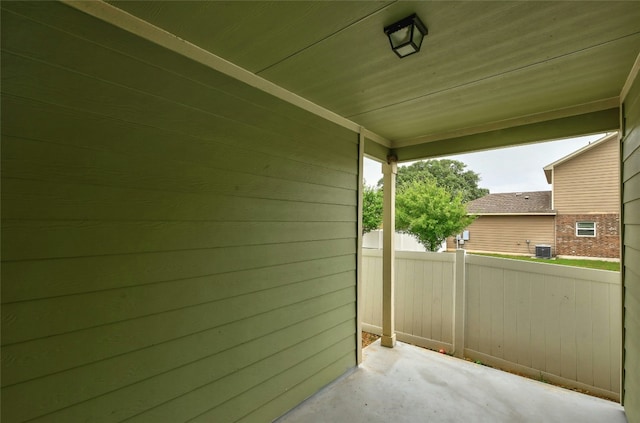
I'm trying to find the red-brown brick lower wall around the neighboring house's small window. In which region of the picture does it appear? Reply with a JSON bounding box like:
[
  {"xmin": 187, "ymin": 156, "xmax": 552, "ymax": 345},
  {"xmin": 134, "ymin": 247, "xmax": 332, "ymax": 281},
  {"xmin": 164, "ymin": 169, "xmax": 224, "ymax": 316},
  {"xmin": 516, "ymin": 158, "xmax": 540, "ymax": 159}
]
[{"xmin": 555, "ymin": 213, "xmax": 620, "ymax": 258}]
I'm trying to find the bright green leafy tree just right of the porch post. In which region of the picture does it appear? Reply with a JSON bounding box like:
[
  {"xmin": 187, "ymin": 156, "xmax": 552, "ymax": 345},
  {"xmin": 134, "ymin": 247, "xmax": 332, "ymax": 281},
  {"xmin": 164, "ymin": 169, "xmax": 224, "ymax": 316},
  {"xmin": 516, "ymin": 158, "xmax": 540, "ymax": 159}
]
[{"xmin": 396, "ymin": 179, "xmax": 475, "ymax": 251}]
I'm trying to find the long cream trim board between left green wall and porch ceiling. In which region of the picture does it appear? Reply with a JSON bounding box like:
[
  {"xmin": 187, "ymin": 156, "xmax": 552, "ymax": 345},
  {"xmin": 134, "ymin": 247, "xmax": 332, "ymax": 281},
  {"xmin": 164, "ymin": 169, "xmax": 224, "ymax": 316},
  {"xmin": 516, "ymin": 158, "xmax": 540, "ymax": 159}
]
[{"xmin": 61, "ymin": 0, "xmax": 391, "ymax": 148}]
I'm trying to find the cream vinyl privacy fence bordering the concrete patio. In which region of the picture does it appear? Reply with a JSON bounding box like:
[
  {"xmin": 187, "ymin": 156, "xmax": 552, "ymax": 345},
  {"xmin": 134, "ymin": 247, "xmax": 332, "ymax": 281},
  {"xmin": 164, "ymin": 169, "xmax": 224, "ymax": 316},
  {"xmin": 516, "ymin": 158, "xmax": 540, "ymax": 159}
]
[{"xmin": 363, "ymin": 249, "xmax": 622, "ymax": 400}]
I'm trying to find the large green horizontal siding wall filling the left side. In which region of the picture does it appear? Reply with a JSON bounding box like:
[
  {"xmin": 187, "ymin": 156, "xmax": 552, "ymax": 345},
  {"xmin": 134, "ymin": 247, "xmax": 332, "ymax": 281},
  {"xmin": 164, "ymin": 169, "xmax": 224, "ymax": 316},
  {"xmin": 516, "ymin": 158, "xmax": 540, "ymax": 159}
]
[{"xmin": 1, "ymin": 2, "xmax": 358, "ymax": 422}]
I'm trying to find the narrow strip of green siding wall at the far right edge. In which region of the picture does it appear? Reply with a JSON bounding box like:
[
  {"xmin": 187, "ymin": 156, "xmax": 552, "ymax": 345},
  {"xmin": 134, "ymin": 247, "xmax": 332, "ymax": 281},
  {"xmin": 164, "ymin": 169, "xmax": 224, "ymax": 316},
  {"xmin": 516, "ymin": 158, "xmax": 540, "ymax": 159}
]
[{"xmin": 621, "ymin": 67, "xmax": 640, "ymax": 423}]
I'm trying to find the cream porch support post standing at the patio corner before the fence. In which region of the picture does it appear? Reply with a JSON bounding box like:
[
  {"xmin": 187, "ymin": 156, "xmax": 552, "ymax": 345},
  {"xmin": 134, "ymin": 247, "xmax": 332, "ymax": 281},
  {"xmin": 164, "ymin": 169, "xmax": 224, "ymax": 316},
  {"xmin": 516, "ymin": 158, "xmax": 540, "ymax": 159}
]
[{"xmin": 380, "ymin": 160, "xmax": 398, "ymax": 348}]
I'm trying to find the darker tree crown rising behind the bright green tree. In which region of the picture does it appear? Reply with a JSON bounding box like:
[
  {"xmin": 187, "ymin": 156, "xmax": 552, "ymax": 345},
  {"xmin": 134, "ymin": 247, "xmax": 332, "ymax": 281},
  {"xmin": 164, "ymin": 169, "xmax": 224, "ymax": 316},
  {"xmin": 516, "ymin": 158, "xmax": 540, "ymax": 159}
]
[{"xmin": 378, "ymin": 159, "xmax": 489, "ymax": 203}]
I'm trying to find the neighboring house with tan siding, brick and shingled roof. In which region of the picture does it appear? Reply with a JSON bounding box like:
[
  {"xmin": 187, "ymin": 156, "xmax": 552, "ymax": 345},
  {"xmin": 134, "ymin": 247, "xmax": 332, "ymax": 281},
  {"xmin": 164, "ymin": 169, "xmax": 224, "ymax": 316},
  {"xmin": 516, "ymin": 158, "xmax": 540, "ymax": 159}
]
[{"xmin": 447, "ymin": 133, "xmax": 620, "ymax": 259}]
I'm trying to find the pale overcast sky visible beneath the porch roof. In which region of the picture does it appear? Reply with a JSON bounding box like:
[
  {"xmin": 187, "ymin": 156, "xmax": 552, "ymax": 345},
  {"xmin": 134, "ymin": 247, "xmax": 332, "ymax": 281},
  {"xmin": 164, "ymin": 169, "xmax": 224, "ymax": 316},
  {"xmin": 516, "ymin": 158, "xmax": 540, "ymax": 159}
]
[{"xmin": 364, "ymin": 135, "xmax": 604, "ymax": 194}]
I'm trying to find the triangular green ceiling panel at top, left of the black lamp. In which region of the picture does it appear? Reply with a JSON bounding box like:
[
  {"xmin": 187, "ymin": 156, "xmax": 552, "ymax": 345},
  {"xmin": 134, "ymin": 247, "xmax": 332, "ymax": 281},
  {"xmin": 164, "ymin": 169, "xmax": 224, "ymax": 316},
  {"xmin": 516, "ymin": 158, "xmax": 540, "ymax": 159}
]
[{"xmin": 107, "ymin": 1, "xmax": 391, "ymax": 74}]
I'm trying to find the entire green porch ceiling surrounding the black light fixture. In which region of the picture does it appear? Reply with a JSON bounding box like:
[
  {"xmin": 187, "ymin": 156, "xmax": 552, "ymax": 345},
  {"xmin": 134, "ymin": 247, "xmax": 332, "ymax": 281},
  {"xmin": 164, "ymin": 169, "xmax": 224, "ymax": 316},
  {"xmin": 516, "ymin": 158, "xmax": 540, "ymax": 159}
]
[{"xmin": 106, "ymin": 1, "xmax": 640, "ymax": 145}]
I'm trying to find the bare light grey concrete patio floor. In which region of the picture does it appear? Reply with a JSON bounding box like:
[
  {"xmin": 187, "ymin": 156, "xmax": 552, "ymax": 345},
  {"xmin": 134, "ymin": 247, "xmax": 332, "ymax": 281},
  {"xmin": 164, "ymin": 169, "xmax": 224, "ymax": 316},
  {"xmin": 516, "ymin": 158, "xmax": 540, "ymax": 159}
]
[{"xmin": 276, "ymin": 340, "xmax": 627, "ymax": 423}]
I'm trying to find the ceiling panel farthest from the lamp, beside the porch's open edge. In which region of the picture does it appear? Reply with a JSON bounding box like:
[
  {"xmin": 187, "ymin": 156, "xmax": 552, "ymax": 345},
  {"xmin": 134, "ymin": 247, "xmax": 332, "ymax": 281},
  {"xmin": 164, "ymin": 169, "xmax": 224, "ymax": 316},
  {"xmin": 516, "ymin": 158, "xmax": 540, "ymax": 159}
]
[{"xmin": 349, "ymin": 33, "xmax": 640, "ymax": 140}]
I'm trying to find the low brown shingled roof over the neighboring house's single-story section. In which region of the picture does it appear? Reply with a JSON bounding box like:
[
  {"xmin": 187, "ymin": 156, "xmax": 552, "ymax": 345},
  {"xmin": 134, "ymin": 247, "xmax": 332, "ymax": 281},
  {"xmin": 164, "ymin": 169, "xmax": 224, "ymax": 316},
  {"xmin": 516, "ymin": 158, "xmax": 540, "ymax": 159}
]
[{"xmin": 467, "ymin": 191, "xmax": 555, "ymax": 215}]
